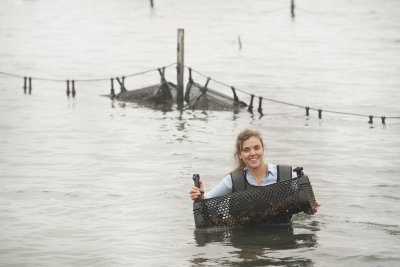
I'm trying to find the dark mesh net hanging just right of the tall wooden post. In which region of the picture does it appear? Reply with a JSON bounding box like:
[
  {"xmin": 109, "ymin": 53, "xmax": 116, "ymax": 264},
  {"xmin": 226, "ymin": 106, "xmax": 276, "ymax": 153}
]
[{"xmin": 185, "ymin": 80, "xmax": 246, "ymax": 111}]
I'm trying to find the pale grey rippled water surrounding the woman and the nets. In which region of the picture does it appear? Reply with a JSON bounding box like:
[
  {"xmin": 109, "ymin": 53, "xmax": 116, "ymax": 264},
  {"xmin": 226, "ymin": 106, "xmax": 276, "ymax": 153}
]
[{"xmin": 0, "ymin": 0, "xmax": 400, "ymax": 266}]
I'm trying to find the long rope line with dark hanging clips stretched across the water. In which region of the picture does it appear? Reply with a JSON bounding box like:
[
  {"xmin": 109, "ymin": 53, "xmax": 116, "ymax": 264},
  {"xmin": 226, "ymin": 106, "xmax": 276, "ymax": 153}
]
[{"xmin": 0, "ymin": 63, "xmax": 400, "ymax": 124}]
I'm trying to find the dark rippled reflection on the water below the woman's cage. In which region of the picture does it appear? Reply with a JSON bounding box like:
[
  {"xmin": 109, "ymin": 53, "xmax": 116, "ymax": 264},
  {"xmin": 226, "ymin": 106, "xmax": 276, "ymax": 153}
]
[{"xmin": 192, "ymin": 224, "xmax": 319, "ymax": 266}]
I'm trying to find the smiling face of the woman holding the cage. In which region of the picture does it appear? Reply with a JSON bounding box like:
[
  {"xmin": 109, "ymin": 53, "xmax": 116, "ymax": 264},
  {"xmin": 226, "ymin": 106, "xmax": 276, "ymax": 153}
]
[{"xmin": 239, "ymin": 136, "xmax": 264, "ymax": 170}]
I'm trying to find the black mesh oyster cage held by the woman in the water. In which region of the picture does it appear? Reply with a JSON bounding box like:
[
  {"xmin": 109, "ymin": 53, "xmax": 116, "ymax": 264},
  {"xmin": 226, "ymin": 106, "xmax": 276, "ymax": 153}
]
[{"xmin": 193, "ymin": 176, "xmax": 316, "ymax": 228}]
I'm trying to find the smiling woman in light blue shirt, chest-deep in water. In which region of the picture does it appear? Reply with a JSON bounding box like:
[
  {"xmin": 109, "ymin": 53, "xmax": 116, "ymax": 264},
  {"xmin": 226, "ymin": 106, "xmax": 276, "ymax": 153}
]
[{"xmin": 189, "ymin": 129, "xmax": 320, "ymax": 217}]
